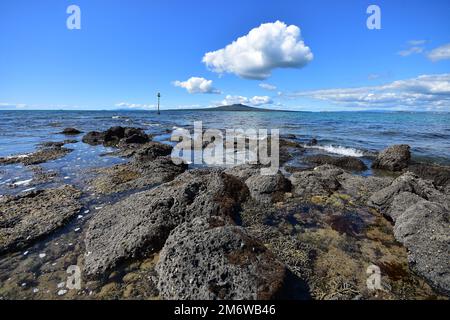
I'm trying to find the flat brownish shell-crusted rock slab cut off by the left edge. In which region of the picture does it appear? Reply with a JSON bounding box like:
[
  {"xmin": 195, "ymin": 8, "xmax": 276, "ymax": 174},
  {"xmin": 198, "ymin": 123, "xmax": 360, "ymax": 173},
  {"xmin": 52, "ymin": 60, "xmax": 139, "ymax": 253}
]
[{"xmin": 0, "ymin": 185, "xmax": 81, "ymax": 252}]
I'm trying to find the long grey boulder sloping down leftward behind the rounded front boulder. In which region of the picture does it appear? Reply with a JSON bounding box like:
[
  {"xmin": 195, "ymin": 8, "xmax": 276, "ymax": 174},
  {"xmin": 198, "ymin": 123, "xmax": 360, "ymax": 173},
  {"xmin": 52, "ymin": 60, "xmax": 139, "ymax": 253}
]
[{"xmin": 85, "ymin": 169, "xmax": 248, "ymax": 275}]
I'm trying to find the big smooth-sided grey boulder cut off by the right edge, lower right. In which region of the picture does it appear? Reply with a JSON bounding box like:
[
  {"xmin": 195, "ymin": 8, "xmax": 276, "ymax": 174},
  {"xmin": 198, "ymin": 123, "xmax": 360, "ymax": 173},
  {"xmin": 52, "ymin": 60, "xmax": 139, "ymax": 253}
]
[{"xmin": 394, "ymin": 200, "xmax": 450, "ymax": 294}]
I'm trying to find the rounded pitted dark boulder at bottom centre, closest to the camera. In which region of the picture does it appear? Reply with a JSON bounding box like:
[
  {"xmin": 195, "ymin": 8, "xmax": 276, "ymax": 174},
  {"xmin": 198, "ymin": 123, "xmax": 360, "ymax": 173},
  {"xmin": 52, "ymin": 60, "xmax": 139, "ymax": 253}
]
[{"xmin": 156, "ymin": 217, "xmax": 286, "ymax": 300}]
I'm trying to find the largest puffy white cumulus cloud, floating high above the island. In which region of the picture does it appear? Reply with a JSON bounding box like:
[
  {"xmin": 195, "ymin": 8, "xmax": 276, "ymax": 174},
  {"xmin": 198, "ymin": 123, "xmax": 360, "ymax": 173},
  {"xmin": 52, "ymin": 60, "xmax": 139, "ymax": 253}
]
[{"xmin": 202, "ymin": 21, "xmax": 313, "ymax": 80}]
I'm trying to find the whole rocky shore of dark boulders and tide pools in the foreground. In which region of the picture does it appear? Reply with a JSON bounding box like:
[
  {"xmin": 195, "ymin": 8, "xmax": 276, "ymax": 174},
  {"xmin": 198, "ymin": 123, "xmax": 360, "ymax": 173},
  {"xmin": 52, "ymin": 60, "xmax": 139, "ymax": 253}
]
[{"xmin": 0, "ymin": 127, "xmax": 450, "ymax": 299}]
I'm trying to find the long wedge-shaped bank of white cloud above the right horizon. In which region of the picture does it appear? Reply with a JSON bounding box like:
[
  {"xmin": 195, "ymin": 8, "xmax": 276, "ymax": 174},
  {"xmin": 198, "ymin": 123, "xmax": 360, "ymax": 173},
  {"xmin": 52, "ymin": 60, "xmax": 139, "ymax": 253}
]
[{"xmin": 285, "ymin": 73, "xmax": 450, "ymax": 110}]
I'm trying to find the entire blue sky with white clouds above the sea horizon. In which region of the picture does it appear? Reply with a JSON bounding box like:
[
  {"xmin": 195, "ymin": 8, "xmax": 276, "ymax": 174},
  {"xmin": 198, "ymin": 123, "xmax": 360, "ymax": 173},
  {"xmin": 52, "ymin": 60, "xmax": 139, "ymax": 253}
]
[{"xmin": 0, "ymin": 0, "xmax": 450, "ymax": 111}]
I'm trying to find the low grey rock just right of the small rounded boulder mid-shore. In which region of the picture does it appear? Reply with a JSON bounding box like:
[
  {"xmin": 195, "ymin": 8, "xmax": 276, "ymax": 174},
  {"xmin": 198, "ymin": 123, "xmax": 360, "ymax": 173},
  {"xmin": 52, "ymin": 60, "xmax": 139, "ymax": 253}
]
[{"xmin": 290, "ymin": 165, "xmax": 344, "ymax": 197}]
